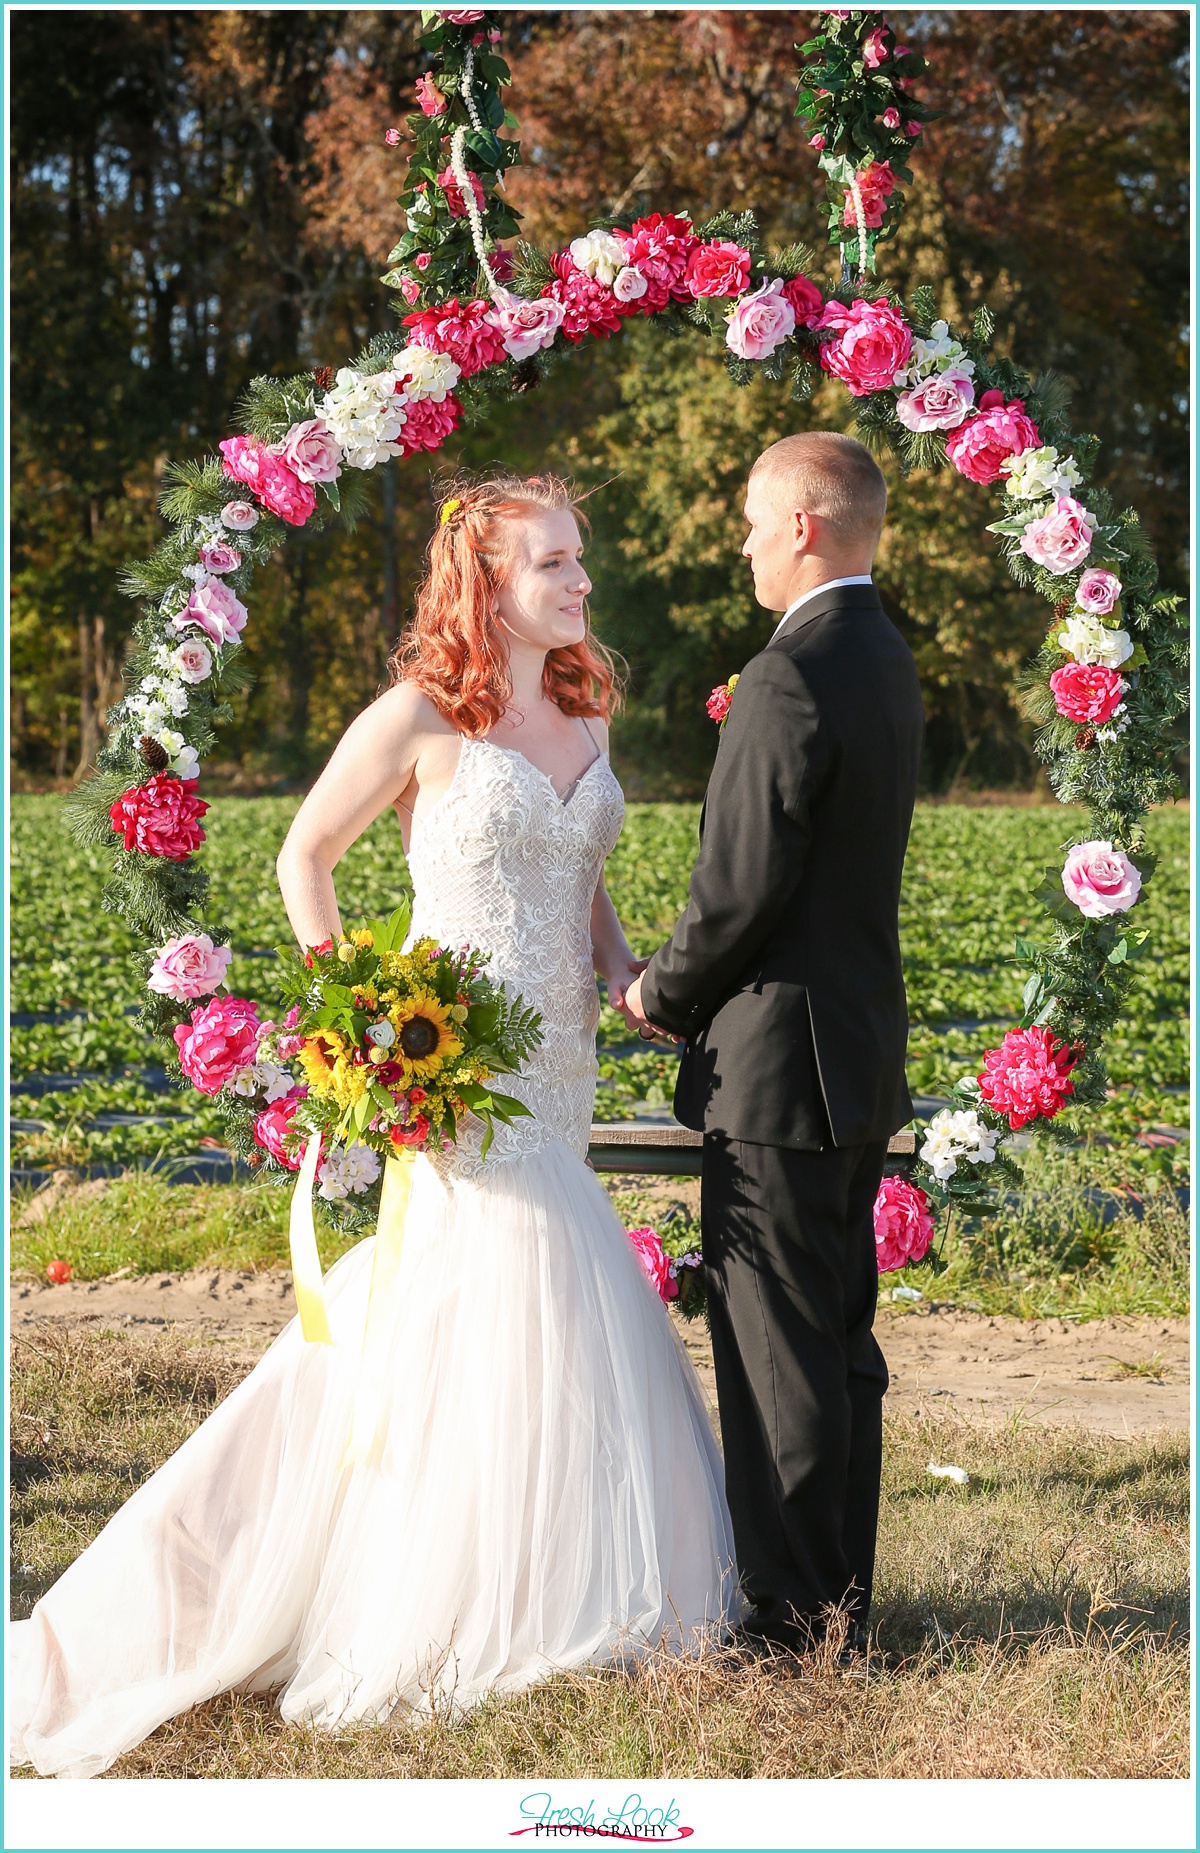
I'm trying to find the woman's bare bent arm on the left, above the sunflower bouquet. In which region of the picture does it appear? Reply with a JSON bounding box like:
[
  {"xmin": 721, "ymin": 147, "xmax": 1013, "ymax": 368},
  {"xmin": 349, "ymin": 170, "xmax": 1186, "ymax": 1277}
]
[{"xmin": 276, "ymin": 682, "xmax": 430, "ymax": 947}]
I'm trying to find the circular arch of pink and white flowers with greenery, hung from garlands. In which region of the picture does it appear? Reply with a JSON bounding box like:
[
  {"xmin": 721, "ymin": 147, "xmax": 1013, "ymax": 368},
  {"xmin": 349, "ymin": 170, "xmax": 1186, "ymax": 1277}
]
[{"xmin": 70, "ymin": 7, "xmax": 1187, "ymax": 1237}]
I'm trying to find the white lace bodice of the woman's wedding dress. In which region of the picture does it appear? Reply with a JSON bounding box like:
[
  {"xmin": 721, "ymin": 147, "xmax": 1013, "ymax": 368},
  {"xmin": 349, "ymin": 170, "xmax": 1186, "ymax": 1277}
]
[{"xmin": 407, "ymin": 739, "xmax": 624, "ymax": 1177}]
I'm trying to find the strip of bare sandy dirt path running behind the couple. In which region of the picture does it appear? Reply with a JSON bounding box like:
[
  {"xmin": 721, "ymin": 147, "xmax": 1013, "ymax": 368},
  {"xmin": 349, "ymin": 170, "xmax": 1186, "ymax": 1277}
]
[{"xmin": 9, "ymin": 1267, "xmax": 1191, "ymax": 1434}]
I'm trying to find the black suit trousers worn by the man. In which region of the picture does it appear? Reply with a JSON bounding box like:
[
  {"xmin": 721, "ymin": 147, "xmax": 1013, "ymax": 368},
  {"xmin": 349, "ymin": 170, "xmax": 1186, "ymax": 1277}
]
[{"xmin": 700, "ymin": 1134, "xmax": 887, "ymax": 1627}]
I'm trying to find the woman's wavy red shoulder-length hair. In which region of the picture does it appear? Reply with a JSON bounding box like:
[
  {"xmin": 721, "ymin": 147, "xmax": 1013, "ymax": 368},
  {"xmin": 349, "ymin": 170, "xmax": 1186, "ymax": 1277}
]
[{"xmin": 387, "ymin": 471, "xmax": 620, "ymax": 737}]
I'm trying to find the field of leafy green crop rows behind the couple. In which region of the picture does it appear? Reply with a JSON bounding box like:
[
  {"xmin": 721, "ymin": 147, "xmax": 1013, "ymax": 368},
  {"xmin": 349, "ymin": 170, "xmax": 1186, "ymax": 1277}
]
[{"xmin": 9, "ymin": 797, "xmax": 1189, "ymax": 1186}]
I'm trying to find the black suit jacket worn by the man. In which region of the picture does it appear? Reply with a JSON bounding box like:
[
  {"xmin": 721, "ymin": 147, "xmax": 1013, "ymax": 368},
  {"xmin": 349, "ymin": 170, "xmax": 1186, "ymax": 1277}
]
[{"xmin": 643, "ymin": 586, "xmax": 924, "ymax": 1151}]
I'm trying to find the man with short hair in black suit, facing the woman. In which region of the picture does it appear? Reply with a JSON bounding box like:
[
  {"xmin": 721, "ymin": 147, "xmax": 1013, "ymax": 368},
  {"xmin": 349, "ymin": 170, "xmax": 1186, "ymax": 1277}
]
[{"xmin": 626, "ymin": 432, "xmax": 924, "ymax": 1647}]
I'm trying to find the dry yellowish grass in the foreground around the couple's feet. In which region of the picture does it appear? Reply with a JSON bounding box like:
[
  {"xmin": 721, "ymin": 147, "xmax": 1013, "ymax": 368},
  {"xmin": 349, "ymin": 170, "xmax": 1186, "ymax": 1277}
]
[{"xmin": 13, "ymin": 1327, "xmax": 1189, "ymax": 1779}]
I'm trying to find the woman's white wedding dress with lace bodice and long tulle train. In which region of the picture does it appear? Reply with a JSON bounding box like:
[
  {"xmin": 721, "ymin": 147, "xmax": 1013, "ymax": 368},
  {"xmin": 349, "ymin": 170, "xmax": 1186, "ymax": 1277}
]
[{"xmin": 9, "ymin": 739, "xmax": 741, "ymax": 1777}]
